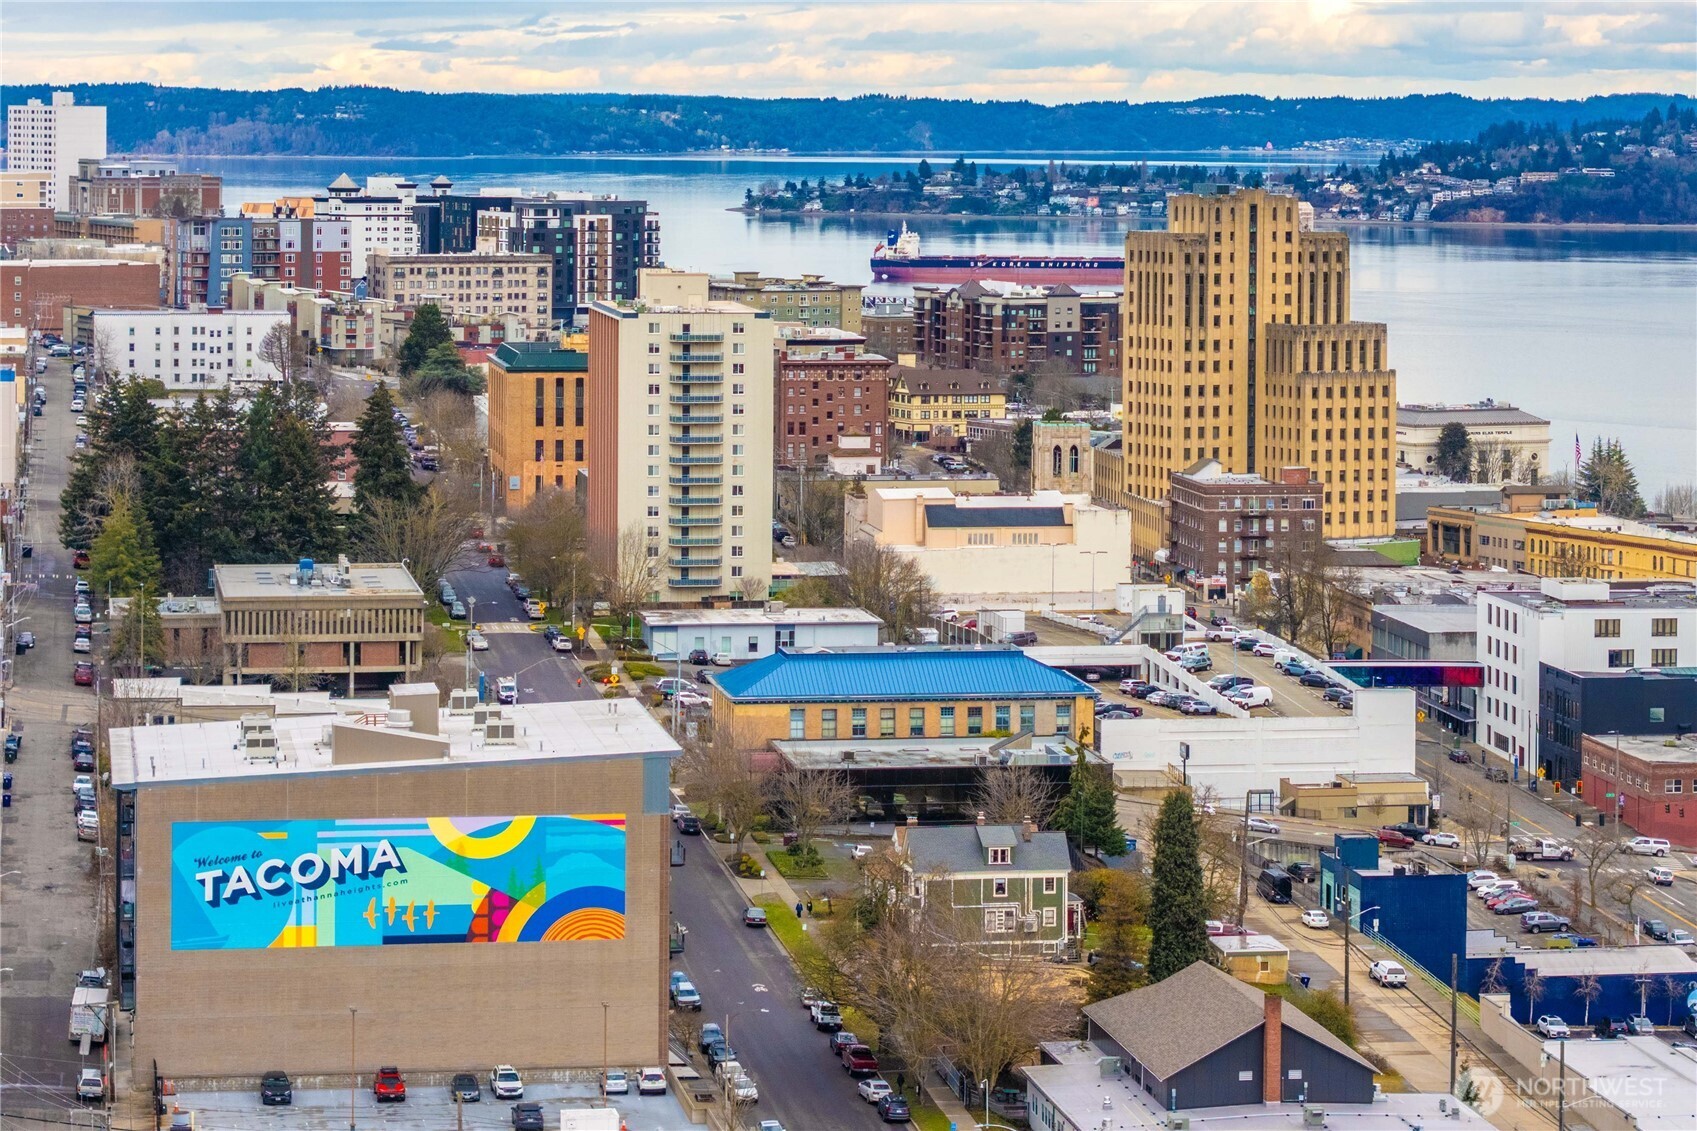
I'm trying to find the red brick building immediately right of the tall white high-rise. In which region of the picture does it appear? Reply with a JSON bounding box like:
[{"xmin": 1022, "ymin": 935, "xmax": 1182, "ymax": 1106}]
[{"xmin": 772, "ymin": 328, "xmax": 889, "ymax": 464}]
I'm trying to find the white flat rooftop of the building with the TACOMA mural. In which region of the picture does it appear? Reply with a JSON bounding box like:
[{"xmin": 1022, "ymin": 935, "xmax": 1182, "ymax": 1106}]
[{"xmin": 110, "ymin": 698, "xmax": 679, "ymax": 788}]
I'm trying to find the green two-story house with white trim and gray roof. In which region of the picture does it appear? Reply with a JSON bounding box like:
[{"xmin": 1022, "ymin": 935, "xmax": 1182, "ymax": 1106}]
[{"xmin": 896, "ymin": 817, "xmax": 1084, "ymax": 954}]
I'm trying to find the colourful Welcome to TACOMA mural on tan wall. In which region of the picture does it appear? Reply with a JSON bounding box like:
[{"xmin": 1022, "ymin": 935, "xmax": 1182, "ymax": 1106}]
[{"xmin": 171, "ymin": 813, "xmax": 624, "ymax": 951}]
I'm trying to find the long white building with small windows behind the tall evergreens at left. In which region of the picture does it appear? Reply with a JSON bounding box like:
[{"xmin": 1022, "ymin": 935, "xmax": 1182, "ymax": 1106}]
[{"xmin": 92, "ymin": 311, "xmax": 288, "ymax": 394}]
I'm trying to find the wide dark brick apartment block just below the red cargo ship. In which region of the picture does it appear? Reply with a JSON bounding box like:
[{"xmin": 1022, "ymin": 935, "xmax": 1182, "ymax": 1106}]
[{"xmin": 913, "ymin": 280, "xmax": 1120, "ymax": 375}]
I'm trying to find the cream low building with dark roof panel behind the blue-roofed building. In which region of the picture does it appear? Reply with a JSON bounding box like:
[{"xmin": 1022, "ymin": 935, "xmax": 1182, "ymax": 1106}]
[{"xmin": 843, "ymin": 486, "xmax": 1132, "ymax": 610}]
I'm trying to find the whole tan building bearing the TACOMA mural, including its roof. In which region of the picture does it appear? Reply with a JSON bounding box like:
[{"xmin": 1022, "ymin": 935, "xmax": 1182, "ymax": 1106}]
[{"xmin": 107, "ymin": 684, "xmax": 677, "ymax": 1094}]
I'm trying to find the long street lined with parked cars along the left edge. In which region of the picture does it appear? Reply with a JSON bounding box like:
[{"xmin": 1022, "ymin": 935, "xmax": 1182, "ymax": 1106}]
[{"xmin": 0, "ymin": 349, "xmax": 100, "ymax": 1128}]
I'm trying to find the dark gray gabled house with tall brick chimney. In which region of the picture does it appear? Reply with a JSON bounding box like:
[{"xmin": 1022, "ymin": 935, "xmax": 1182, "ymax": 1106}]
[{"xmin": 1084, "ymin": 963, "xmax": 1373, "ymax": 1109}]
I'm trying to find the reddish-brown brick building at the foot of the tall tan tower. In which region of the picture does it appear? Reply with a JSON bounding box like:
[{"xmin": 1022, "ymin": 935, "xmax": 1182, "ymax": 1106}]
[{"xmin": 1168, "ymin": 459, "xmax": 1322, "ymax": 591}]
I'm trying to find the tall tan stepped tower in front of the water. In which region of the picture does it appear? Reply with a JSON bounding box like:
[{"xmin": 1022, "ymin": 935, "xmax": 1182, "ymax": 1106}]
[{"xmin": 1123, "ymin": 189, "xmax": 1397, "ymax": 554}]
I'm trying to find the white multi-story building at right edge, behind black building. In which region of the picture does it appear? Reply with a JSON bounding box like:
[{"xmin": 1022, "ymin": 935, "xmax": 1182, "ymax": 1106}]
[{"xmin": 1475, "ymin": 577, "xmax": 1697, "ymax": 766}]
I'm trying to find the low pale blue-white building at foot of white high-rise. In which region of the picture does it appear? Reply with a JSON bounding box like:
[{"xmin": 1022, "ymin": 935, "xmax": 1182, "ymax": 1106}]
[{"xmin": 636, "ymin": 601, "xmax": 884, "ymax": 664}]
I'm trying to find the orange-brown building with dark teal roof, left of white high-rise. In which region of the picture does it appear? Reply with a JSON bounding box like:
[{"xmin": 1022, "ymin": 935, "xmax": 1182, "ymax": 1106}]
[{"xmin": 489, "ymin": 341, "xmax": 589, "ymax": 513}]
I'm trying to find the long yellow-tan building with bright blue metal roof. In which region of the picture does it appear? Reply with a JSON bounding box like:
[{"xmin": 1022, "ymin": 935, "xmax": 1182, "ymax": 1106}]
[{"xmin": 711, "ymin": 647, "xmax": 1095, "ymax": 751}]
